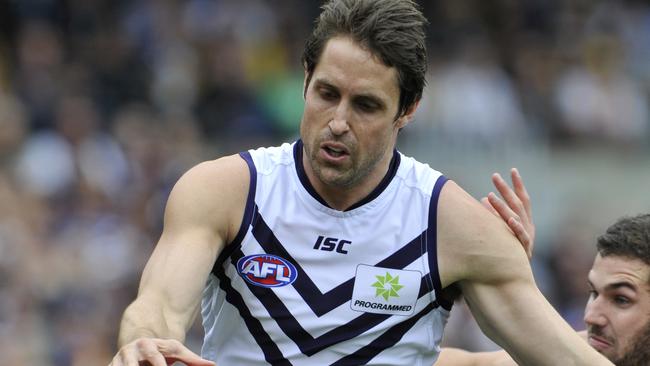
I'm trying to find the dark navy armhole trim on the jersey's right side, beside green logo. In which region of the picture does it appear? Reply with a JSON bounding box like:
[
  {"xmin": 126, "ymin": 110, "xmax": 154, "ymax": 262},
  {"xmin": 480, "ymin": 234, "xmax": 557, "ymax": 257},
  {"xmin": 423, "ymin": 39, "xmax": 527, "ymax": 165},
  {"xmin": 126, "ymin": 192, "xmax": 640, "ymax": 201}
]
[{"xmin": 426, "ymin": 175, "xmax": 453, "ymax": 311}]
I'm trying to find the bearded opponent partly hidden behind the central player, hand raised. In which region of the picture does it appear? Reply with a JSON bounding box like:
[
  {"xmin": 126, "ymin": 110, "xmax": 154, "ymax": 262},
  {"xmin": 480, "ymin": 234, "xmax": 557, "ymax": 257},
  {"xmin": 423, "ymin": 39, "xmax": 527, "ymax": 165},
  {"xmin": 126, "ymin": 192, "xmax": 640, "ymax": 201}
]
[{"xmin": 435, "ymin": 169, "xmax": 650, "ymax": 366}]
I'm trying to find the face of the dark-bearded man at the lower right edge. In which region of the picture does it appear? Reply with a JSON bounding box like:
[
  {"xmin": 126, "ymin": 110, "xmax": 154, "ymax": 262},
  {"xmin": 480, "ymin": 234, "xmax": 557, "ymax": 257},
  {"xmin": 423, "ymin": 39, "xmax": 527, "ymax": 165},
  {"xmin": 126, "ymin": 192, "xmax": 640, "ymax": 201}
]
[{"xmin": 585, "ymin": 255, "xmax": 650, "ymax": 362}]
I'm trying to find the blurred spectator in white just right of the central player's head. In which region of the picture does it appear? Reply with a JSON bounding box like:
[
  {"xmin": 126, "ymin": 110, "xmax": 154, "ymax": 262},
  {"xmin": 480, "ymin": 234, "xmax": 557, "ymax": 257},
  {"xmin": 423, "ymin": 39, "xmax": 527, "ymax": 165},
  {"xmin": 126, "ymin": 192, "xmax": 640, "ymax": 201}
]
[{"xmin": 421, "ymin": 39, "xmax": 527, "ymax": 144}]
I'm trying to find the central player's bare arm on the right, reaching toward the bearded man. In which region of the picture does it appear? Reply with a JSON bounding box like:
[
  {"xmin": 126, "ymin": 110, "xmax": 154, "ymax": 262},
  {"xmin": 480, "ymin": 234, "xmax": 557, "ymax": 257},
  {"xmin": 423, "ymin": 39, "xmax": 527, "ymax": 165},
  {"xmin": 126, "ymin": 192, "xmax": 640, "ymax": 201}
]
[{"xmin": 438, "ymin": 182, "xmax": 611, "ymax": 366}]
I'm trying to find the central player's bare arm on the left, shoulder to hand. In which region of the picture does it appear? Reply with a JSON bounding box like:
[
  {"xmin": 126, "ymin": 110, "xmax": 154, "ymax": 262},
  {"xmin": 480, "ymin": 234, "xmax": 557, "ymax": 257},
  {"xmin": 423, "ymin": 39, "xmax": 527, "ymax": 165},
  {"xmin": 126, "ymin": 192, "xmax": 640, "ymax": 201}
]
[{"xmin": 111, "ymin": 156, "xmax": 249, "ymax": 366}]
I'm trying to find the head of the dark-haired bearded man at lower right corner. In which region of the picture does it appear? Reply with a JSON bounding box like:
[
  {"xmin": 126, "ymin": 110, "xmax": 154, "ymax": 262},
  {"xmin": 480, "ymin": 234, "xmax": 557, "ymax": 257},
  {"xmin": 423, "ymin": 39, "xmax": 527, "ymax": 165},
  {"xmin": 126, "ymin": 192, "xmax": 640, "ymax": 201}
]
[{"xmin": 585, "ymin": 214, "xmax": 650, "ymax": 366}]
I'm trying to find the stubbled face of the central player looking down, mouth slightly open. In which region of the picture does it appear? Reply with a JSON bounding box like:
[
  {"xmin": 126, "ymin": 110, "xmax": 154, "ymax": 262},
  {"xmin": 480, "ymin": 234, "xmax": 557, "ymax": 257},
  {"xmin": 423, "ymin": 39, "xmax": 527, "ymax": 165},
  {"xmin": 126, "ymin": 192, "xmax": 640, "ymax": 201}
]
[{"xmin": 300, "ymin": 37, "xmax": 410, "ymax": 196}]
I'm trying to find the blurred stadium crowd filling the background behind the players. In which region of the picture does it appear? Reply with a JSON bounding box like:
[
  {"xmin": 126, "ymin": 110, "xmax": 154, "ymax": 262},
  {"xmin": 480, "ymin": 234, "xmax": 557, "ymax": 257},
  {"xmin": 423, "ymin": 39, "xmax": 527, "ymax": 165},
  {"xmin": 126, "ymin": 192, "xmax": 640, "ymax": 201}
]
[{"xmin": 0, "ymin": 0, "xmax": 650, "ymax": 366}]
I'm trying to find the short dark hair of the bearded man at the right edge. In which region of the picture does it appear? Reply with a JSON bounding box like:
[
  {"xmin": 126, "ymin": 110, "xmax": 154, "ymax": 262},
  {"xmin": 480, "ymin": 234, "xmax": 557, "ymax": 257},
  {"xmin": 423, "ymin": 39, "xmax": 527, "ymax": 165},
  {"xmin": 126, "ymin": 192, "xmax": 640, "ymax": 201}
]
[{"xmin": 597, "ymin": 214, "xmax": 650, "ymax": 266}]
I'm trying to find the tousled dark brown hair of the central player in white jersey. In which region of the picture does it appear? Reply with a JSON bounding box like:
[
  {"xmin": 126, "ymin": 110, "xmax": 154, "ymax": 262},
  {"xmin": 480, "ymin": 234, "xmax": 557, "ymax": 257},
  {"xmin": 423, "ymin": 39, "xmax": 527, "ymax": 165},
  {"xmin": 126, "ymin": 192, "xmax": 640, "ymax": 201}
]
[{"xmin": 302, "ymin": 0, "xmax": 427, "ymax": 116}]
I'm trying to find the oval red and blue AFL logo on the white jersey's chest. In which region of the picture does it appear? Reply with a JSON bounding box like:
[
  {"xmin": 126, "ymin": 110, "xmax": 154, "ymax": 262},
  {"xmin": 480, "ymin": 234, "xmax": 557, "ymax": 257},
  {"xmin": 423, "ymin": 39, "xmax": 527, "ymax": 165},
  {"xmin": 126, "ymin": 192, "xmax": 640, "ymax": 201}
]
[{"xmin": 237, "ymin": 254, "xmax": 298, "ymax": 287}]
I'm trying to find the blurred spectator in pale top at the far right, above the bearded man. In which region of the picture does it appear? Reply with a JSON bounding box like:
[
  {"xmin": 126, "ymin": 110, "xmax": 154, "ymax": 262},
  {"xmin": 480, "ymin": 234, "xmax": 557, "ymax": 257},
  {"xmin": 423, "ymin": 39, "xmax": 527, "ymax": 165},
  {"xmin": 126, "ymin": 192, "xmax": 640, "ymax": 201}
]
[{"xmin": 556, "ymin": 34, "xmax": 650, "ymax": 145}]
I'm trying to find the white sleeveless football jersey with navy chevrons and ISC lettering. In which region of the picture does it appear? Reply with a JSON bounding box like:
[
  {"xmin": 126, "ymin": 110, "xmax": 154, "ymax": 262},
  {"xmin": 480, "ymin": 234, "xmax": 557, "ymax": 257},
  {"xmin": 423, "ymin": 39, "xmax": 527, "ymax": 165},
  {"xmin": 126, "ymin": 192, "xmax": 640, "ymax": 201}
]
[{"xmin": 201, "ymin": 140, "xmax": 451, "ymax": 366}]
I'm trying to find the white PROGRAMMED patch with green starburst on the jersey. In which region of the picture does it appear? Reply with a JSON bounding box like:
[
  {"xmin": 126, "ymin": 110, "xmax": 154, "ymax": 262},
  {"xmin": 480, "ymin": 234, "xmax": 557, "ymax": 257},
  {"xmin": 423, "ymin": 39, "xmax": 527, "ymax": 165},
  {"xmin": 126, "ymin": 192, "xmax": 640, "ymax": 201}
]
[{"xmin": 350, "ymin": 264, "xmax": 422, "ymax": 315}]
